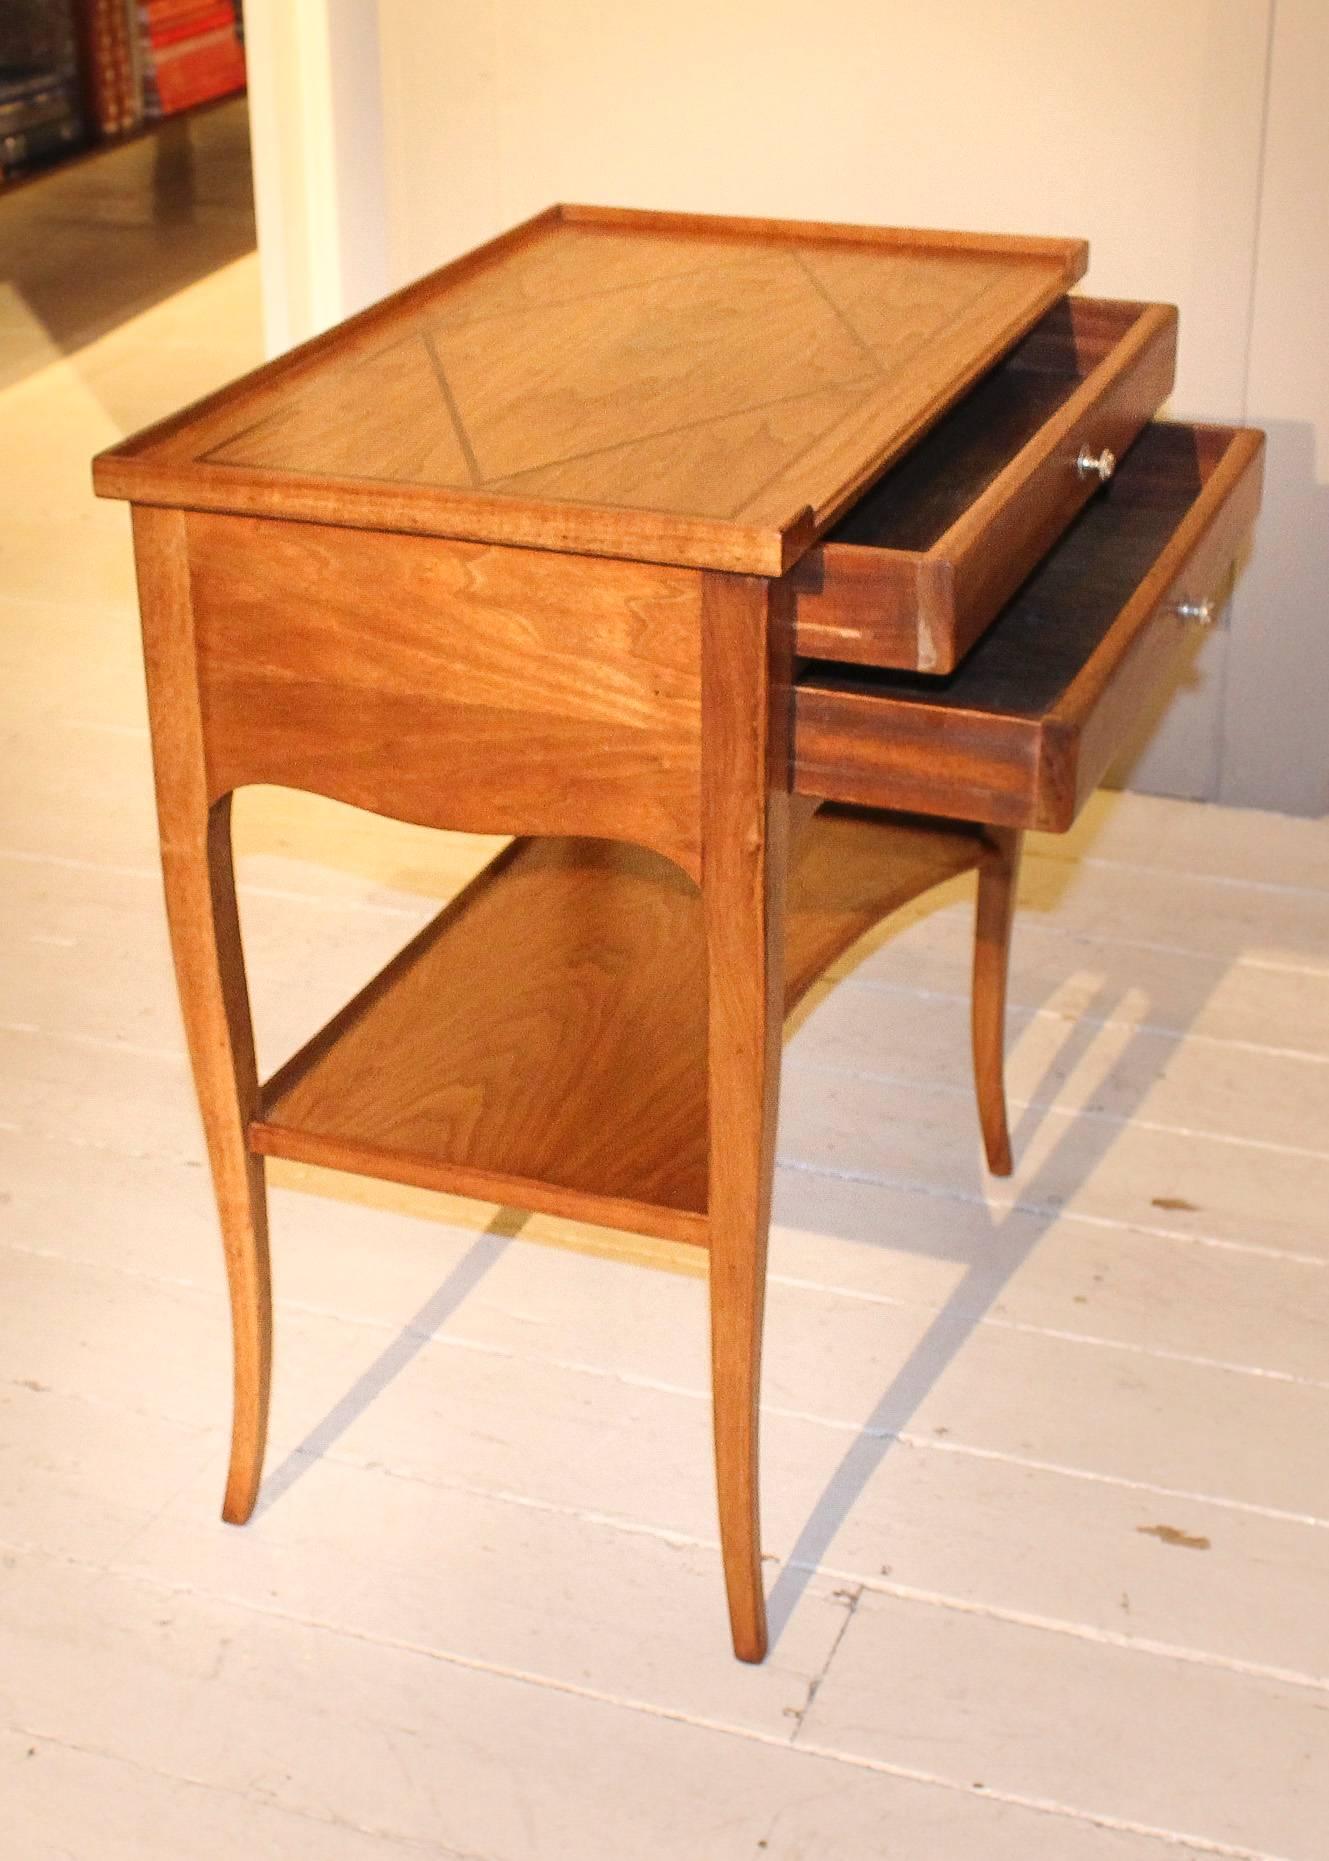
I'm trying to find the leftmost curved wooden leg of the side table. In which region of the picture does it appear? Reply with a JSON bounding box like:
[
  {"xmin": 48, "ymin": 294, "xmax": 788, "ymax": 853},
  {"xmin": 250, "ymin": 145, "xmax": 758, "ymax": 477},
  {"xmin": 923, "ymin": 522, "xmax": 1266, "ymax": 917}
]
[{"xmin": 134, "ymin": 510, "xmax": 272, "ymax": 1524}]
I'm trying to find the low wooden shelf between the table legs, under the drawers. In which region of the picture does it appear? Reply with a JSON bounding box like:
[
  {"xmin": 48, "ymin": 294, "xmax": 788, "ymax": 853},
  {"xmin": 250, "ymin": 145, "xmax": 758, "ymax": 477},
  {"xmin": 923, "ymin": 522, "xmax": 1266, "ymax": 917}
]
[{"xmin": 249, "ymin": 810, "xmax": 983, "ymax": 1245}]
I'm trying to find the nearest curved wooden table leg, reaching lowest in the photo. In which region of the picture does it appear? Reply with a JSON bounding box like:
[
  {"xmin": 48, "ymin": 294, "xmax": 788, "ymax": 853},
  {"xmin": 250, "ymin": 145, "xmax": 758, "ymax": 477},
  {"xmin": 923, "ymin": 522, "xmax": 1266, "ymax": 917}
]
[{"xmin": 702, "ymin": 575, "xmax": 793, "ymax": 1660}]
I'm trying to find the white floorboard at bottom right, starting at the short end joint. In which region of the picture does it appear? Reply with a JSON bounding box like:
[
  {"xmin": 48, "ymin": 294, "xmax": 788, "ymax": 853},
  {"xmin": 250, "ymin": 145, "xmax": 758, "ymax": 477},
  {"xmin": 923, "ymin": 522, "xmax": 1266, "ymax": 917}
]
[{"xmin": 800, "ymin": 1597, "xmax": 1329, "ymax": 1861}]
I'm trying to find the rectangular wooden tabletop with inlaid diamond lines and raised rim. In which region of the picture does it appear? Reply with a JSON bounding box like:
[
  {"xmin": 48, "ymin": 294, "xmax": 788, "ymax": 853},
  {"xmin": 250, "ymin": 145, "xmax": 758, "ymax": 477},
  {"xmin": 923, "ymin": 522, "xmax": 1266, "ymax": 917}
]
[{"xmin": 95, "ymin": 208, "xmax": 1083, "ymax": 566}]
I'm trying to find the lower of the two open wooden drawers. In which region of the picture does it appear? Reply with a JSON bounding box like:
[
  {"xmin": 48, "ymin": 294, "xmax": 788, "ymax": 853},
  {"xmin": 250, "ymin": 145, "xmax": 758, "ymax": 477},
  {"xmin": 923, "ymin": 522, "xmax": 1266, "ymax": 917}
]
[{"xmin": 795, "ymin": 422, "xmax": 1264, "ymax": 832}]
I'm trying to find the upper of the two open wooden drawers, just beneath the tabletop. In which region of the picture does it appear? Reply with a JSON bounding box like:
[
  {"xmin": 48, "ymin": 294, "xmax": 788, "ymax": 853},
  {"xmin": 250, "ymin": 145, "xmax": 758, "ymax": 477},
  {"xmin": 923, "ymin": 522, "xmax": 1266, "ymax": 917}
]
[{"xmin": 795, "ymin": 298, "xmax": 1176, "ymax": 672}]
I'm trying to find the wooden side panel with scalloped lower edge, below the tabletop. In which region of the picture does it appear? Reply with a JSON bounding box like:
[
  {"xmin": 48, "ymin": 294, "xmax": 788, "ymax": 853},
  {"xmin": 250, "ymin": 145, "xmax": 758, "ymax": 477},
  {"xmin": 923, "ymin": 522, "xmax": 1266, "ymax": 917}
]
[{"xmin": 186, "ymin": 514, "xmax": 702, "ymax": 873}]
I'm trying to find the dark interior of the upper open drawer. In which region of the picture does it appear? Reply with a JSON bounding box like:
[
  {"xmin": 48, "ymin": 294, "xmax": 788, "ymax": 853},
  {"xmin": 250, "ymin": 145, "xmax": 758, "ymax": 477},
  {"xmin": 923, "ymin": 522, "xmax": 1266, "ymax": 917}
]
[{"xmin": 825, "ymin": 298, "xmax": 1150, "ymax": 553}]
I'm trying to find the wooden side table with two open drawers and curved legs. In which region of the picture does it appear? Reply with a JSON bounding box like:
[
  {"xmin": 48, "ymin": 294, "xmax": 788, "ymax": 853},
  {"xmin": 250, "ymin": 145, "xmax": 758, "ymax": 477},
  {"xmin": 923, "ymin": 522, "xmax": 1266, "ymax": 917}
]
[{"xmin": 95, "ymin": 207, "xmax": 1260, "ymax": 1660}]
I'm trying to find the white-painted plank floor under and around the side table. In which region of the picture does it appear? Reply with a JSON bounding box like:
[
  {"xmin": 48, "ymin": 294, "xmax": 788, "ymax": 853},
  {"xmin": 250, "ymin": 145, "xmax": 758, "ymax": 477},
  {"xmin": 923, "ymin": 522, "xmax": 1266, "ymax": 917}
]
[{"xmin": 0, "ymin": 261, "xmax": 1329, "ymax": 1861}]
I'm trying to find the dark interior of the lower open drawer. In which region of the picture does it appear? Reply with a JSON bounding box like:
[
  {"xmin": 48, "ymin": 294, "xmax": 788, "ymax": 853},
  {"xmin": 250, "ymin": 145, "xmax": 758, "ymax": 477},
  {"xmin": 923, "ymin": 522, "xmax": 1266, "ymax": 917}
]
[{"xmin": 800, "ymin": 422, "xmax": 1230, "ymax": 716}]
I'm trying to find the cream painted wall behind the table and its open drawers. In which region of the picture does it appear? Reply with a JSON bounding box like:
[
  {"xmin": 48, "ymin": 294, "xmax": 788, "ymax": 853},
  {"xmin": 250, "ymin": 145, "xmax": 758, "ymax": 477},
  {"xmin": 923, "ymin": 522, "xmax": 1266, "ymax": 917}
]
[{"xmin": 243, "ymin": 0, "xmax": 1329, "ymax": 811}]
